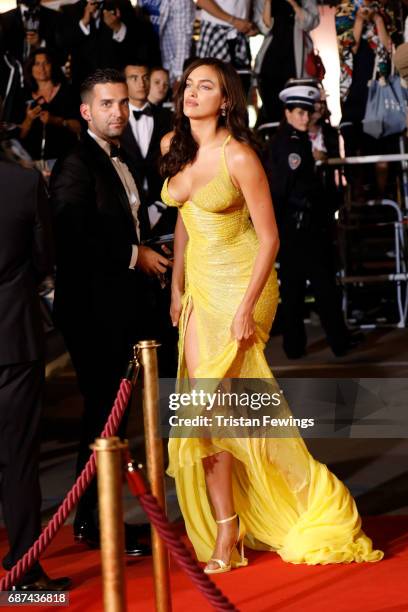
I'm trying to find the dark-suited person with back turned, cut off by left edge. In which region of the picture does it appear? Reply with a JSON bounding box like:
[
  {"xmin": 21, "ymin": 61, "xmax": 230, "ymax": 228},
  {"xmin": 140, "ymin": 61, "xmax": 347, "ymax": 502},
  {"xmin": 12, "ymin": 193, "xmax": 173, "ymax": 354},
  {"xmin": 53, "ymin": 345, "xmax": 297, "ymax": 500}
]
[{"xmin": 0, "ymin": 141, "xmax": 71, "ymax": 591}]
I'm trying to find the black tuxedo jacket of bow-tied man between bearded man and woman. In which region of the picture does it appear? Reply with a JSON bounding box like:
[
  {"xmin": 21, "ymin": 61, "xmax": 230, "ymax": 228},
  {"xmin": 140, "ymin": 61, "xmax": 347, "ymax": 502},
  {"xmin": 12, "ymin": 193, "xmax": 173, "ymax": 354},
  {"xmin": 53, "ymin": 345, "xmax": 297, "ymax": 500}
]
[{"xmin": 121, "ymin": 104, "xmax": 177, "ymax": 235}]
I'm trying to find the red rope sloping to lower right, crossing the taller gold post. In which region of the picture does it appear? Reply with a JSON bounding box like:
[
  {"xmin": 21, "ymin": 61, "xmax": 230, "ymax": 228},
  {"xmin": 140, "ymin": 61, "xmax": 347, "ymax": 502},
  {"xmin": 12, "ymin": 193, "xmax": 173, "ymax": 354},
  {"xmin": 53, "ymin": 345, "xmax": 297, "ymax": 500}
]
[{"xmin": 127, "ymin": 470, "xmax": 239, "ymax": 612}]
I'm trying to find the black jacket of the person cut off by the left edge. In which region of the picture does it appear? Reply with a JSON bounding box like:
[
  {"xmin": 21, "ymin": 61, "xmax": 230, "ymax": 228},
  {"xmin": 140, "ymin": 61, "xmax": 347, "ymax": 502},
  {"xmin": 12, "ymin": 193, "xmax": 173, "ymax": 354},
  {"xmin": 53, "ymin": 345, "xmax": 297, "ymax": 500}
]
[{"xmin": 0, "ymin": 160, "xmax": 52, "ymax": 365}]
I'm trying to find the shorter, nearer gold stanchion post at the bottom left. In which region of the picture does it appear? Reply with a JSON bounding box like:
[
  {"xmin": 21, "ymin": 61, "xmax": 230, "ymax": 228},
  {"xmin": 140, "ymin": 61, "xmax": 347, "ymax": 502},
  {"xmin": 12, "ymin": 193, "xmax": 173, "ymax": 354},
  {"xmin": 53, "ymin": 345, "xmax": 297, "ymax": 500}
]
[{"xmin": 91, "ymin": 437, "xmax": 127, "ymax": 612}]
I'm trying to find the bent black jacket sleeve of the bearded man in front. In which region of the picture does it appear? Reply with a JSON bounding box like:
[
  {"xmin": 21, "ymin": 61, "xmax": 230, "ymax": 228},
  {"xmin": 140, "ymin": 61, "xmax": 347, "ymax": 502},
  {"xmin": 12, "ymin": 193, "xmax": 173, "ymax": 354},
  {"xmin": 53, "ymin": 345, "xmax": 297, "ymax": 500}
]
[{"xmin": 50, "ymin": 155, "xmax": 132, "ymax": 270}]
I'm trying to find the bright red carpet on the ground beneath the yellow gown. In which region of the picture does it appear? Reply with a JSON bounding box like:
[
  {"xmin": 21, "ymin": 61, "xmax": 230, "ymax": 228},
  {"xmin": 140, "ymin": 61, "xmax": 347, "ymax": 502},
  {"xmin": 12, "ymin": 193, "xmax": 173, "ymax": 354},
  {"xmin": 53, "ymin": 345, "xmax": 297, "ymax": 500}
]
[{"xmin": 0, "ymin": 516, "xmax": 408, "ymax": 612}]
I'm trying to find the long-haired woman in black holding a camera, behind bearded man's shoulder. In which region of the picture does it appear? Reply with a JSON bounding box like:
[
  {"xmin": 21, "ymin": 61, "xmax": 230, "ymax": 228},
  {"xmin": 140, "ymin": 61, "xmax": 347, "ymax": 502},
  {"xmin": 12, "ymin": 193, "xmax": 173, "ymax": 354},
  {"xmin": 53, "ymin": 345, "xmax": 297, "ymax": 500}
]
[{"xmin": 20, "ymin": 48, "xmax": 81, "ymax": 160}]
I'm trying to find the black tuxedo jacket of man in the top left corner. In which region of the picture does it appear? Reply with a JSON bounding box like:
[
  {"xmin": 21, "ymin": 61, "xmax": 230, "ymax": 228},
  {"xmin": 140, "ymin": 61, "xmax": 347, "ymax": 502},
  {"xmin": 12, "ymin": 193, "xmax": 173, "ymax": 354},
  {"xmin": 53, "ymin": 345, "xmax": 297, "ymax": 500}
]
[{"xmin": 0, "ymin": 6, "xmax": 66, "ymax": 65}]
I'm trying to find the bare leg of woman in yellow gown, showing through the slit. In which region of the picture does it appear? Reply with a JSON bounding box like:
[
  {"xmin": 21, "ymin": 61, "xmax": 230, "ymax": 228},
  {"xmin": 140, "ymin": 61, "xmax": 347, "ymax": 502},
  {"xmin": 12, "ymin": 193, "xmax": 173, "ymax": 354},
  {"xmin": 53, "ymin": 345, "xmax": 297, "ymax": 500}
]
[{"xmin": 184, "ymin": 308, "xmax": 238, "ymax": 569}]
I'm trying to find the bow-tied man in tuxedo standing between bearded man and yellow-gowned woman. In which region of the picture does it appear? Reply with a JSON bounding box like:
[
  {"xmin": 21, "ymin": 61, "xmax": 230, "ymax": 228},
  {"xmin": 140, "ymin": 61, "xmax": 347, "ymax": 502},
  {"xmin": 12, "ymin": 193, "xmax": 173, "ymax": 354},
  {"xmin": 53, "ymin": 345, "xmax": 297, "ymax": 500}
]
[{"xmin": 121, "ymin": 63, "xmax": 177, "ymax": 236}]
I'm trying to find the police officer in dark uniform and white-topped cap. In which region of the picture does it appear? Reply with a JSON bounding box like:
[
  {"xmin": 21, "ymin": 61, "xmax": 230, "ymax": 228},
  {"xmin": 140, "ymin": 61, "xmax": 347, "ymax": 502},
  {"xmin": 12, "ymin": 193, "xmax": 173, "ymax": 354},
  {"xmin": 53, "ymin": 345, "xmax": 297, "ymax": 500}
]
[{"xmin": 269, "ymin": 85, "xmax": 351, "ymax": 359}]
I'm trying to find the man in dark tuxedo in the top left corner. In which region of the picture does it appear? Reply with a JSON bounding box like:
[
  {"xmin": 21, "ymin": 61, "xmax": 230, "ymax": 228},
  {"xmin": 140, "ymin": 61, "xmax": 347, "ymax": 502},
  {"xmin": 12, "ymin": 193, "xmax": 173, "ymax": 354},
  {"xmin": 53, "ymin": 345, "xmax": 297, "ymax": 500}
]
[{"xmin": 0, "ymin": 0, "xmax": 65, "ymax": 64}]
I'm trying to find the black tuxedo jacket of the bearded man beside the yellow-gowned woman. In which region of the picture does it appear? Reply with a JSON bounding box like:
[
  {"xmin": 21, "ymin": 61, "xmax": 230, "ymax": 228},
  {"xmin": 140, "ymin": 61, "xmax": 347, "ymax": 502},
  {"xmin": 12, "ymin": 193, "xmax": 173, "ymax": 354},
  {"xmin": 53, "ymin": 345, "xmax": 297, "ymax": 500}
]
[{"xmin": 50, "ymin": 130, "xmax": 153, "ymax": 359}]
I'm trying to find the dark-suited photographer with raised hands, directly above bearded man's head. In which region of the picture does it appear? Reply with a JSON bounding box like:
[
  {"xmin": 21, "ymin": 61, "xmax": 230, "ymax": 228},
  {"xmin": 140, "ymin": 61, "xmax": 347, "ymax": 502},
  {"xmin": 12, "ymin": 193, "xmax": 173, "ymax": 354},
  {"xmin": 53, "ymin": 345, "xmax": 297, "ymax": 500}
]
[{"xmin": 62, "ymin": 0, "xmax": 135, "ymax": 88}]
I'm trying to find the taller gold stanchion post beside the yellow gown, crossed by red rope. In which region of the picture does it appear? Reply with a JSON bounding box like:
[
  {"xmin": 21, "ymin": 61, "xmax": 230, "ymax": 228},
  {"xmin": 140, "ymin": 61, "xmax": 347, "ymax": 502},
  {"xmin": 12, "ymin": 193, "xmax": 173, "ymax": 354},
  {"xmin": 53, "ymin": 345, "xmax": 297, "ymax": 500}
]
[{"xmin": 137, "ymin": 340, "xmax": 171, "ymax": 612}]
